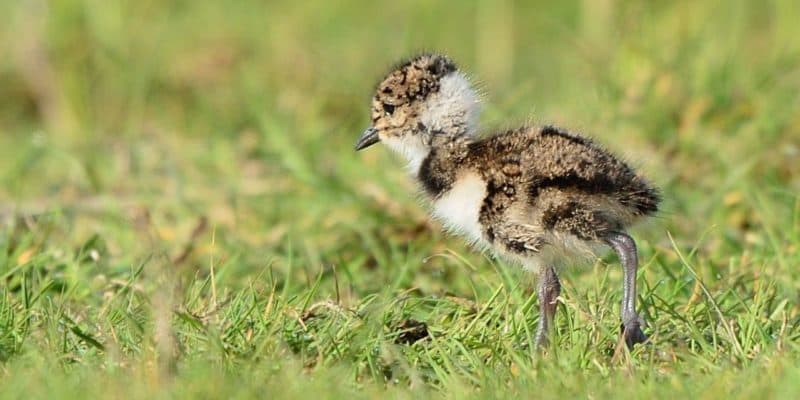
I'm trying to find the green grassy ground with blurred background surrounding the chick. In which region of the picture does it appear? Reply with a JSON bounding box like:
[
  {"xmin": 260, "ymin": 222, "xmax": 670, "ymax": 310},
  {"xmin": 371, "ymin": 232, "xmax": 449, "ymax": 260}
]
[{"xmin": 0, "ymin": 0, "xmax": 800, "ymax": 399}]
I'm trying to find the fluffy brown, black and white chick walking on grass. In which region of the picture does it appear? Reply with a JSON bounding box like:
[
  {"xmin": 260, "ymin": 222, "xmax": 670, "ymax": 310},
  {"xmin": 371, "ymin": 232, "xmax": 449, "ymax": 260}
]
[{"xmin": 355, "ymin": 53, "xmax": 661, "ymax": 349}]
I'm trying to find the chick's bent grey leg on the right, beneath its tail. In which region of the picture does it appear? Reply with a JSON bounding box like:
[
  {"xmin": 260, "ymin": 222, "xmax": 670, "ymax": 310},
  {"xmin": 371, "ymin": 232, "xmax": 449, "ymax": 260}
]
[{"xmin": 605, "ymin": 232, "xmax": 647, "ymax": 349}]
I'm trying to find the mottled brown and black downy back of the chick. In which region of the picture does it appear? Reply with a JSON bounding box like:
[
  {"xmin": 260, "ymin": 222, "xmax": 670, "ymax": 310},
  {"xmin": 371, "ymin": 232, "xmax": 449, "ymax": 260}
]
[{"xmin": 467, "ymin": 126, "xmax": 660, "ymax": 240}]
